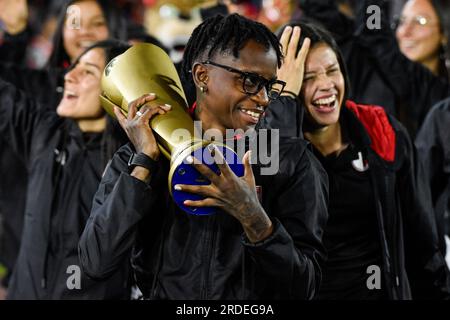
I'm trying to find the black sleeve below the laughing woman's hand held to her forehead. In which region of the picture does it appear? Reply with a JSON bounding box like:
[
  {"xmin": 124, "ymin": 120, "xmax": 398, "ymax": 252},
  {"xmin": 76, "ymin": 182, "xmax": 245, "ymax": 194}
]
[{"xmin": 258, "ymin": 96, "xmax": 304, "ymax": 138}]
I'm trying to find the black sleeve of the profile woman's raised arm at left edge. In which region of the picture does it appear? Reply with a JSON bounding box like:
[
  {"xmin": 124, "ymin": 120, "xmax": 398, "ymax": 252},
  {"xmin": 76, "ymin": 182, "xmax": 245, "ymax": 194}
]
[{"xmin": 0, "ymin": 78, "xmax": 44, "ymax": 162}]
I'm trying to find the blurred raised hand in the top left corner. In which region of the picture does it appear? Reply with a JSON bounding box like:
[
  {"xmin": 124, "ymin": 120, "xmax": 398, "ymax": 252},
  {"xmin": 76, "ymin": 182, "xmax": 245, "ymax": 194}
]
[{"xmin": 0, "ymin": 0, "xmax": 28, "ymax": 35}]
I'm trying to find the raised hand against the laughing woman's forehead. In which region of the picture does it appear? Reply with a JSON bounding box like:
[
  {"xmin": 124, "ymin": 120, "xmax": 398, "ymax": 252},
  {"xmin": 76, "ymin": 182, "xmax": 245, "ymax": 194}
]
[{"xmin": 277, "ymin": 26, "xmax": 311, "ymax": 96}]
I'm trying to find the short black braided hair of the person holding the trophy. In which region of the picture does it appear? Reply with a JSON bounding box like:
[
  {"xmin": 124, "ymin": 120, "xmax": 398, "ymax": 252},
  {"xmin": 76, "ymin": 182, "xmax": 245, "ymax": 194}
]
[{"xmin": 181, "ymin": 14, "xmax": 283, "ymax": 82}]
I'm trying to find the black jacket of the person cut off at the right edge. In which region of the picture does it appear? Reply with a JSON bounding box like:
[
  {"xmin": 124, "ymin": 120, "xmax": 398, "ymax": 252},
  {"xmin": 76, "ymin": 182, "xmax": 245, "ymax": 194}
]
[{"xmin": 415, "ymin": 99, "xmax": 450, "ymax": 253}]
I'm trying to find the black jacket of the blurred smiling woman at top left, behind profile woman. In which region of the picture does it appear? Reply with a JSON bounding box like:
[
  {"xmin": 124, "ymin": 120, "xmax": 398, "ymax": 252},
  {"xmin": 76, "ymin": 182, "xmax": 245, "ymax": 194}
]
[{"xmin": 0, "ymin": 29, "xmax": 64, "ymax": 282}]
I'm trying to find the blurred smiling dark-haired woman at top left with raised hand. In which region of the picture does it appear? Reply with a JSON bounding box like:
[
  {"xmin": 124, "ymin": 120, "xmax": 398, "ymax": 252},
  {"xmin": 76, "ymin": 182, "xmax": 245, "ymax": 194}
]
[{"xmin": 0, "ymin": 0, "xmax": 126, "ymax": 292}]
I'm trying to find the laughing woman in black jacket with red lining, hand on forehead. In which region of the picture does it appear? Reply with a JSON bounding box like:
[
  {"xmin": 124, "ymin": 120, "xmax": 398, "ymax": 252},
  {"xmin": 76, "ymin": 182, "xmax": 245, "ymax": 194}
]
[{"xmin": 265, "ymin": 22, "xmax": 450, "ymax": 300}]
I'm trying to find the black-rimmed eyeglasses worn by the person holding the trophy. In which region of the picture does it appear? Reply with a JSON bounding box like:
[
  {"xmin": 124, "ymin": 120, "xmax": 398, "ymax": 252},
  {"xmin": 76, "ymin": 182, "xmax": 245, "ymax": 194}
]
[{"xmin": 202, "ymin": 60, "xmax": 286, "ymax": 100}]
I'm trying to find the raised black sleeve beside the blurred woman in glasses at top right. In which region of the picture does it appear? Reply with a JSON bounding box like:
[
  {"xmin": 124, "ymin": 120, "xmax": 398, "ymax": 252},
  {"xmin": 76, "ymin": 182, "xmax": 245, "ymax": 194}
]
[{"xmin": 355, "ymin": 0, "xmax": 450, "ymax": 124}]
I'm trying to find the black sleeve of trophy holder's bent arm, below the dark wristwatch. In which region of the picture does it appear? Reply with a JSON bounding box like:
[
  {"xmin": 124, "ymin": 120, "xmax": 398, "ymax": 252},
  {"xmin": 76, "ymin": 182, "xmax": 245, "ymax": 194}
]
[{"xmin": 79, "ymin": 145, "xmax": 163, "ymax": 279}]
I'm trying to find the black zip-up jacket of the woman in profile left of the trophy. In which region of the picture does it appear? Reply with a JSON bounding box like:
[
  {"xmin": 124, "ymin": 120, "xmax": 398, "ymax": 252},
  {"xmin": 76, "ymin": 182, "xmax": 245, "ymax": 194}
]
[{"xmin": 0, "ymin": 79, "xmax": 128, "ymax": 299}]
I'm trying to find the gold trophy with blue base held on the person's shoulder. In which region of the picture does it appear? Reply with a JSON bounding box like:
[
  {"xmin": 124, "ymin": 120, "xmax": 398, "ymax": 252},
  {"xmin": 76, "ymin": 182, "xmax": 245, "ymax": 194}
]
[{"xmin": 100, "ymin": 43, "xmax": 244, "ymax": 215}]
